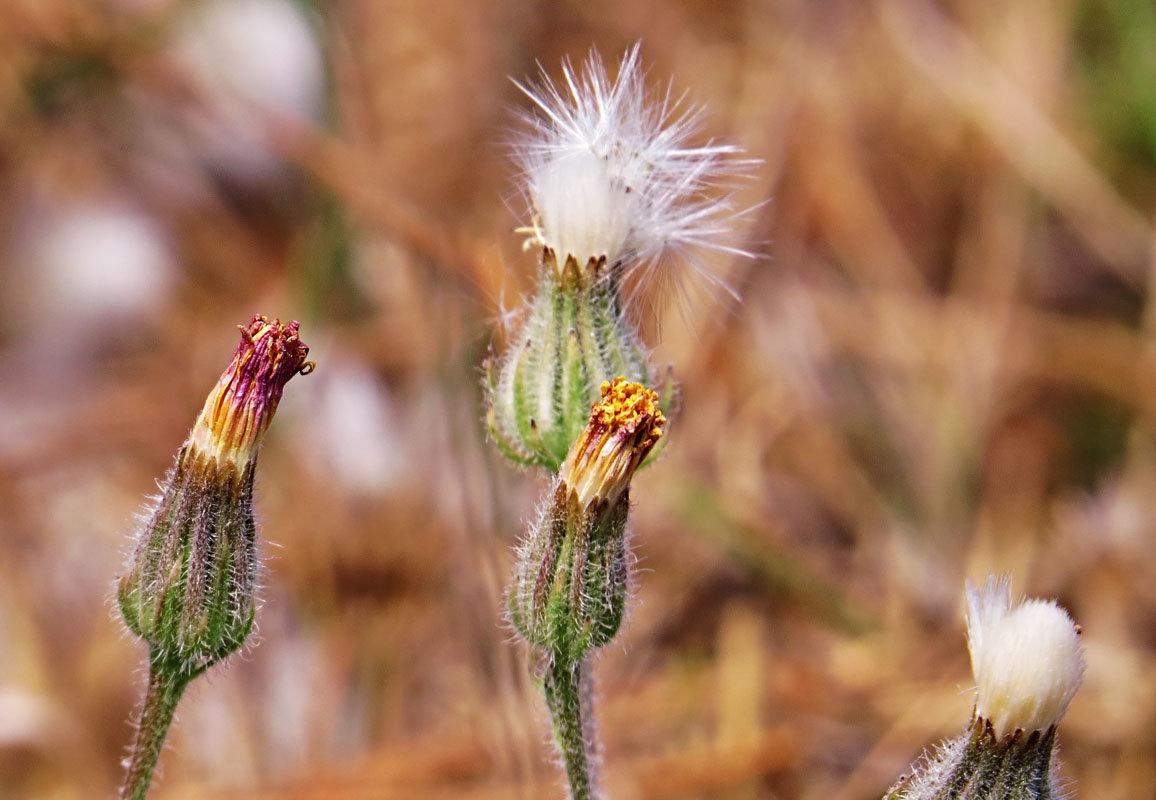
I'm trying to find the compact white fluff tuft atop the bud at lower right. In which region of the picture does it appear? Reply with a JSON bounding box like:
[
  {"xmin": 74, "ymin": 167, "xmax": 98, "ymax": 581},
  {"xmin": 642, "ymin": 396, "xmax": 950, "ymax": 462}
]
[{"xmin": 968, "ymin": 577, "xmax": 1084, "ymax": 736}]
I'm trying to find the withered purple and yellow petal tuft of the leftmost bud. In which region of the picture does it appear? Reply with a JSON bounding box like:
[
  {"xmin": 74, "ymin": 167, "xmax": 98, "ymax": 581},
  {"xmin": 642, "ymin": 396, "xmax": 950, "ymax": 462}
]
[{"xmin": 188, "ymin": 314, "xmax": 313, "ymax": 472}]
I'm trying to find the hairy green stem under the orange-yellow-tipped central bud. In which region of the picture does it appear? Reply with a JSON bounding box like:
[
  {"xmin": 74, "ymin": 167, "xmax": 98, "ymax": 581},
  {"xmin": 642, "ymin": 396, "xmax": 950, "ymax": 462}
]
[{"xmin": 542, "ymin": 658, "xmax": 595, "ymax": 800}]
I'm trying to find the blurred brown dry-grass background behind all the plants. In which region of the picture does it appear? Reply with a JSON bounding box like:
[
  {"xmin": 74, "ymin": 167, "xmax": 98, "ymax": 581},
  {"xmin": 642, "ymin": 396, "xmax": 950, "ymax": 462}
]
[{"xmin": 0, "ymin": 0, "xmax": 1156, "ymax": 800}]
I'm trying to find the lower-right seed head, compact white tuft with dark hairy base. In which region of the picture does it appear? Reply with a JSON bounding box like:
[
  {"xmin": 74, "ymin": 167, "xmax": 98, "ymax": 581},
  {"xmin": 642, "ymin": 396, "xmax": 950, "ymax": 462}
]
[{"xmin": 885, "ymin": 578, "xmax": 1084, "ymax": 800}]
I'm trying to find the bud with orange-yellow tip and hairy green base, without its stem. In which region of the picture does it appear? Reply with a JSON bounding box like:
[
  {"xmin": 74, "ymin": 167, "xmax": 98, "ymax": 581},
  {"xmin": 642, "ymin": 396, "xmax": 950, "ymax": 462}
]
[{"xmin": 507, "ymin": 377, "xmax": 666, "ymax": 662}]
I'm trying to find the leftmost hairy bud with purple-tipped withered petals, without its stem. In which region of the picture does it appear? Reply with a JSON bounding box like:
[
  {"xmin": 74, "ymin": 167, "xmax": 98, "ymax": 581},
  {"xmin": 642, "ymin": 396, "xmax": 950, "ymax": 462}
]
[{"xmin": 118, "ymin": 316, "xmax": 313, "ymax": 673}]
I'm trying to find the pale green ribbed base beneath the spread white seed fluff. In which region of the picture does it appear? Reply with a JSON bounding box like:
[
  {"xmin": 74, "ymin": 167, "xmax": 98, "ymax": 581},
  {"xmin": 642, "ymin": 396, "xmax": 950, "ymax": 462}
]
[{"xmin": 486, "ymin": 253, "xmax": 674, "ymax": 472}]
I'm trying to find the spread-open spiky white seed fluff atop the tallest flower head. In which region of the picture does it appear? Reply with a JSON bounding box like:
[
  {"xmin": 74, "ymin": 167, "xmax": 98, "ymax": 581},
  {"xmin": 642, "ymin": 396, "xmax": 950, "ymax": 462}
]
[{"xmin": 513, "ymin": 45, "xmax": 755, "ymax": 293}]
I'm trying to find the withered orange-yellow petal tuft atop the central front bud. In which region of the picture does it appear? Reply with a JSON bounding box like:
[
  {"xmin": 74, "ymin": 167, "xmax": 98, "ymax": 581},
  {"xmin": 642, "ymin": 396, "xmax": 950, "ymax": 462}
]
[{"xmin": 558, "ymin": 377, "xmax": 666, "ymax": 509}]
